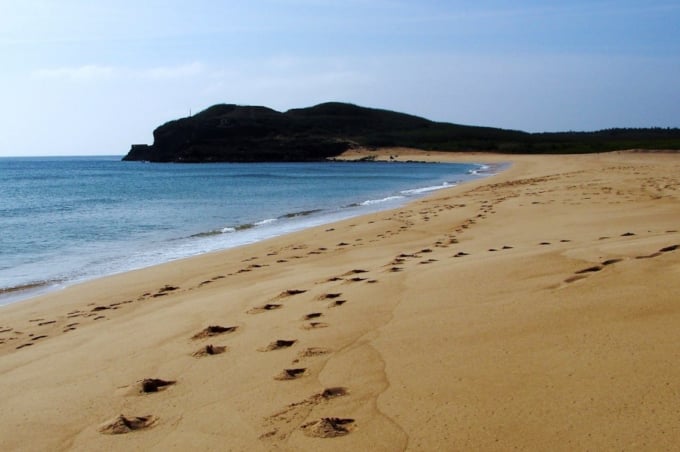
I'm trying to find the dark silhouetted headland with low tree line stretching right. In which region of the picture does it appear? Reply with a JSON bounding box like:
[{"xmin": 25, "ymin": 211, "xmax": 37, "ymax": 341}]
[{"xmin": 124, "ymin": 102, "xmax": 680, "ymax": 162}]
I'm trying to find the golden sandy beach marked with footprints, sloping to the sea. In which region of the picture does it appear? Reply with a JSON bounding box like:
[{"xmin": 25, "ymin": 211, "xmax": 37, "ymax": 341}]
[{"xmin": 0, "ymin": 149, "xmax": 680, "ymax": 451}]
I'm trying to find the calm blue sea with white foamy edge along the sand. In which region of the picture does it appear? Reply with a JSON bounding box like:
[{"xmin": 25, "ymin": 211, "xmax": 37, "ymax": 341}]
[{"xmin": 0, "ymin": 156, "xmax": 482, "ymax": 304}]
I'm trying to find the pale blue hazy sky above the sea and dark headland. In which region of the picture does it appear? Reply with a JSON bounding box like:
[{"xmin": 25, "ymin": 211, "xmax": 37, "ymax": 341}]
[{"xmin": 0, "ymin": 0, "xmax": 680, "ymax": 156}]
